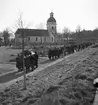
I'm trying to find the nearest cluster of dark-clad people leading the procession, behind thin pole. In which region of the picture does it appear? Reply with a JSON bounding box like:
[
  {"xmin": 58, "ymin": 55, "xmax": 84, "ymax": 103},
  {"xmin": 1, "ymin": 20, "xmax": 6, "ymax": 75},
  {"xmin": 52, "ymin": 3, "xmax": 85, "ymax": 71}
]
[{"xmin": 16, "ymin": 50, "xmax": 38, "ymax": 72}]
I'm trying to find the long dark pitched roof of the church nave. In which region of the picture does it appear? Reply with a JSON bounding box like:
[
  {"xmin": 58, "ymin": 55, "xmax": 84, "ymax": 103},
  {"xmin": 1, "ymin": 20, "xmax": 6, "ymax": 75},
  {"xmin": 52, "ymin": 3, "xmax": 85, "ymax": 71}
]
[{"xmin": 15, "ymin": 28, "xmax": 49, "ymax": 37}]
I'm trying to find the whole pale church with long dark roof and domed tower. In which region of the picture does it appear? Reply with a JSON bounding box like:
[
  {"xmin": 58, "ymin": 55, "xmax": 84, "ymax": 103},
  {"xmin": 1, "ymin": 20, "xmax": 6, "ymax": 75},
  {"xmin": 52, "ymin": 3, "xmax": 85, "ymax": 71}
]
[{"xmin": 15, "ymin": 12, "xmax": 57, "ymax": 45}]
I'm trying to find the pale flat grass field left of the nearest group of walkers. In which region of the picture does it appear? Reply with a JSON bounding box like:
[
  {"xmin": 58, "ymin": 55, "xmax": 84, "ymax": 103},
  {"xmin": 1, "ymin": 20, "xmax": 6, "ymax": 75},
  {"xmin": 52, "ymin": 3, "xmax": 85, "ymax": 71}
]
[{"xmin": 0, "ymin": 46, "xmax": 21, "ymax": 75}]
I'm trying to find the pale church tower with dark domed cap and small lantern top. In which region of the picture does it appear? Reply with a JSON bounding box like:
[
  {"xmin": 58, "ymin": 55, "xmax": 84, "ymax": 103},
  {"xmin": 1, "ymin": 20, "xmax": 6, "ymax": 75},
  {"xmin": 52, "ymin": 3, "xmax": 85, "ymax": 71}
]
[{"xmin": 47, "ymin": 12, "xmax": 56, "ymax": 36}]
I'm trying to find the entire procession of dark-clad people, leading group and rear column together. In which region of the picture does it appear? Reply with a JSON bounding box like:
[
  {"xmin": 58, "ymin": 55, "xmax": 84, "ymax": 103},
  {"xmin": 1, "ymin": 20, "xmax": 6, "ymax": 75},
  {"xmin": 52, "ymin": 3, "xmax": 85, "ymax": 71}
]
[{"xmin": 16, "ymin": 43, "xmax": 91, "ymax": 72}]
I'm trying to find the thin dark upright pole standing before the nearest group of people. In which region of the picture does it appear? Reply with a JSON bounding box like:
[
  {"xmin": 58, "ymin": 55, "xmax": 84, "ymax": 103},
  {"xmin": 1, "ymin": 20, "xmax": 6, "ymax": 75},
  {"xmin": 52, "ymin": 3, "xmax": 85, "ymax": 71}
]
[{"xmin": 22, "ymin": 32, "xmax": 26, "ymax": 90}]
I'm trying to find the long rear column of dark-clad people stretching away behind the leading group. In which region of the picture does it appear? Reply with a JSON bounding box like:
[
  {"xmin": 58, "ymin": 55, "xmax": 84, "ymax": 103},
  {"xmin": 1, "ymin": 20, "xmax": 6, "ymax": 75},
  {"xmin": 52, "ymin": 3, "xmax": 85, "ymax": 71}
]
[{"xmin": 48, "ymin": 43, "xmax": 92, "ymax": 60}]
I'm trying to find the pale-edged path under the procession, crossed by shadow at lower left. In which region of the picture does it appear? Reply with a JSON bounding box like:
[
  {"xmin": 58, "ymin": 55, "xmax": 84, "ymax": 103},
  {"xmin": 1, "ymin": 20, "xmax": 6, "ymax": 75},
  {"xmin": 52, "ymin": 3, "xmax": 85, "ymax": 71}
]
[{"xmin": 0, "ymin": 55, "xmax": 63, "ymax": 91}]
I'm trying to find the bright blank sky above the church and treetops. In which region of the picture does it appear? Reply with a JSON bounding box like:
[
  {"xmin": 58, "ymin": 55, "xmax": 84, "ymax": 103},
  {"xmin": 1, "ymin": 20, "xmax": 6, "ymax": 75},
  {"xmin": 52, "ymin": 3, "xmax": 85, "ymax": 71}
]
[{"xmin": 0, "ymin": 0, "xmax": 98, "ymax": 31}]
